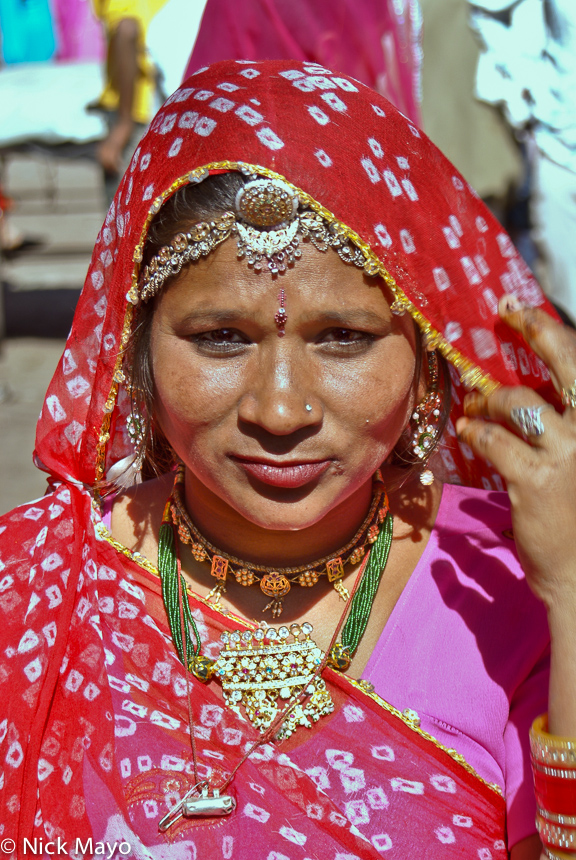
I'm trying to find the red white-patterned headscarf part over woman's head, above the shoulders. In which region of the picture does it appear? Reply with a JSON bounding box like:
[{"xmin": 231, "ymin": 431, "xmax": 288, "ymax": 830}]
[{"xmin": 36, "ymin": 61, "xmax": 551, "ymax": 488}]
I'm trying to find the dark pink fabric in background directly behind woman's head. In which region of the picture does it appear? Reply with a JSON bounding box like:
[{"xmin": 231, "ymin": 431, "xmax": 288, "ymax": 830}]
[{"xmin": 183, "ymin": 0, "xmax": 421, "ymax": 125}]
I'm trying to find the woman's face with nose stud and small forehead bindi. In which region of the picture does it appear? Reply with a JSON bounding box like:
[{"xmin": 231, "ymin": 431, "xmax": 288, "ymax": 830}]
[{"xmin": 151, "ymin": 241, "xmax": 415, "ymax": 530}]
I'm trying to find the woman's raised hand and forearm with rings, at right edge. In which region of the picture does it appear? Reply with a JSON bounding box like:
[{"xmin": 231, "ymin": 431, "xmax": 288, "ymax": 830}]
[{"xmin": 457, "ymin": 296, "xmax": 576, "ymax": 736}]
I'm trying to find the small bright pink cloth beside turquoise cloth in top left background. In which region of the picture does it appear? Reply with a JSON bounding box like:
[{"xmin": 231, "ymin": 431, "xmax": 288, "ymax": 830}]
[{"xmin": 50, "ymin": 0, "xmax": 106, "ymax": 62}]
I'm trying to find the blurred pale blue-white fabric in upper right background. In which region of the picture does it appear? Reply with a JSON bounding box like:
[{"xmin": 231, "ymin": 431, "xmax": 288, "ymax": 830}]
[{"xmin": 471, "ymin": 0, "xmax": 576, "ymax": 322}]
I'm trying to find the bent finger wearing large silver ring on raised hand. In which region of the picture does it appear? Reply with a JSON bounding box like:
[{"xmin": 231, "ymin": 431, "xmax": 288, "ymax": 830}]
[{"xmin": 464, "ymin": 386, "xmax": 562, "ymax": 448}]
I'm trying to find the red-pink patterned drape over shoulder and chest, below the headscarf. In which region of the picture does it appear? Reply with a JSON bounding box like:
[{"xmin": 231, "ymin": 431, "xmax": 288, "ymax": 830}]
[{"xmin": 0, "ymin": 488, "xmax": 506, "ymax": 860}]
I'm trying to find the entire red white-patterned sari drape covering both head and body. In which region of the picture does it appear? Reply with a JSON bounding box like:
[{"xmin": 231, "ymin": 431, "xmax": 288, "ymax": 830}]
[{"xmin": 0, "ymin": 61, "xmax": 552, "ymax": 860}]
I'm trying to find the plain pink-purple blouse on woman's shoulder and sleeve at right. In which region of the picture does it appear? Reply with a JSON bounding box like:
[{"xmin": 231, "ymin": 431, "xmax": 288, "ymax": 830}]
[{"xmin": 363, "ymin": 484, "xmax": 549, "ymax": 846}]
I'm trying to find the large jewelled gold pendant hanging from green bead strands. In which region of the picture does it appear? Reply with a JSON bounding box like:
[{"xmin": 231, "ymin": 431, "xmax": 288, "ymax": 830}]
[{"xmin": 214, "ymin": 622, "xmax": 334, "ymax": 739}]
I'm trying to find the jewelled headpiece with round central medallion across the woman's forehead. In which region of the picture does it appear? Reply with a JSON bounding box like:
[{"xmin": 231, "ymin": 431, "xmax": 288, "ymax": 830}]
[{"xmin": 140, "ymin": 178, "xmax": 377, "ymax": 302}]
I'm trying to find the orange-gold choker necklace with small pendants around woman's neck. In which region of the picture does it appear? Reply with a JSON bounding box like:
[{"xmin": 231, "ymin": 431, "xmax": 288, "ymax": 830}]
[{"xmin": 170, "ymin": 466, "xmax": 389, "ymax": 618}]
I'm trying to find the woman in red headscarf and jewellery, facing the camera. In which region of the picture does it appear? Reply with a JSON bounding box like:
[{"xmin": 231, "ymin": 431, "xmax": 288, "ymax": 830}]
[{"xmin": 0, "ymin": 62, "xmax": 576, "ymax": 860}]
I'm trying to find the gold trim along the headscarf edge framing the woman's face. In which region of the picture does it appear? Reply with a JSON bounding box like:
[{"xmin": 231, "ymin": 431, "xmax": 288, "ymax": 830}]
[{"xmin": 95, "ymin": 161, "xmax": 499, "ymax": 483}]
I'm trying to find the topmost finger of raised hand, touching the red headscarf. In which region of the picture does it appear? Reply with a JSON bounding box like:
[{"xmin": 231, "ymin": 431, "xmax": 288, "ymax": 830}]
[{"xmin": 498, "ymin": 296, "xmax": 576, "ymax": 393}]
